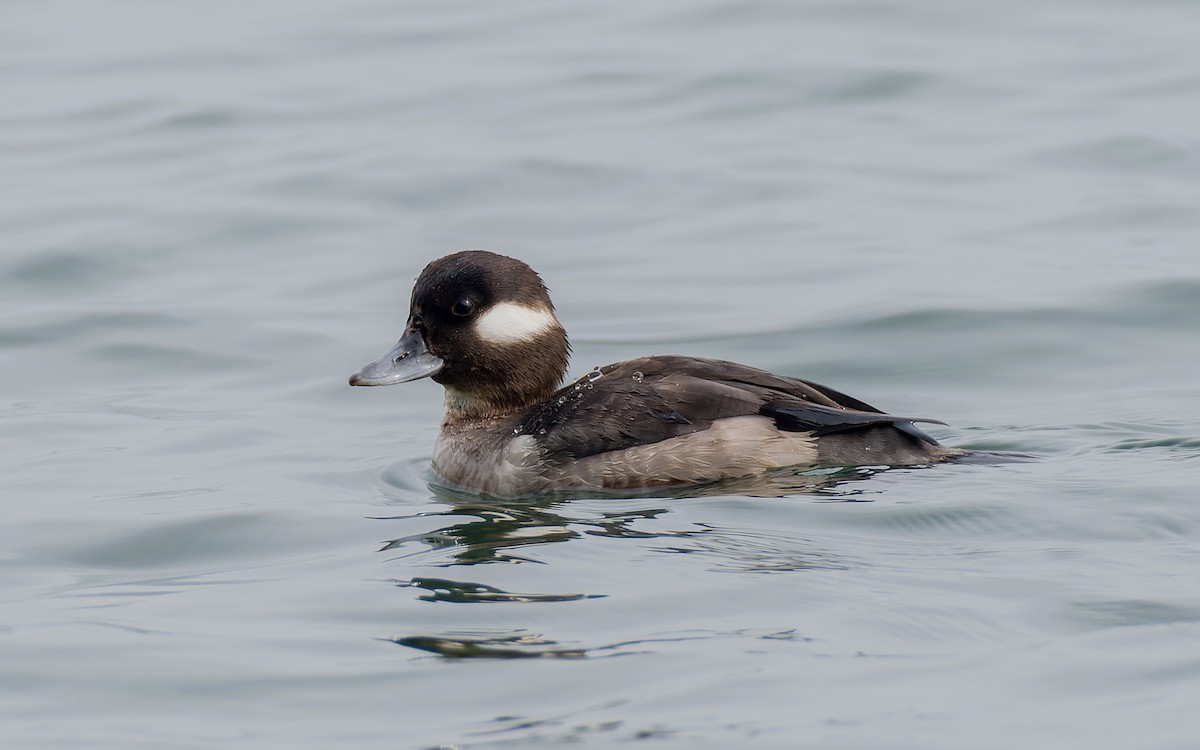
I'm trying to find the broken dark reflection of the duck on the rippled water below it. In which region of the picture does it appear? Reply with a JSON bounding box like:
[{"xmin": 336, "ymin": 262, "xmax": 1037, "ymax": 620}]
[{"xmin": 382, "ymin": 469, "xmax": 875, "ymax": 659}]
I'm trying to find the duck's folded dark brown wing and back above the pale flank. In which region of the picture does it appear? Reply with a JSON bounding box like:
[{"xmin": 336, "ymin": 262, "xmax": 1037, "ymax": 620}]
[{"xmin": 520, "ymin": 356, "xmax": 943, "ymax": 458}]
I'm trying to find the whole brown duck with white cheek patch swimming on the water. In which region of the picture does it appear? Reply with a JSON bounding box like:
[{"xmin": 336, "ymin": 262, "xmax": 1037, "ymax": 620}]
[{"xmin": 350, "ymin": 250, "xmax": 965, "ymax": 497}]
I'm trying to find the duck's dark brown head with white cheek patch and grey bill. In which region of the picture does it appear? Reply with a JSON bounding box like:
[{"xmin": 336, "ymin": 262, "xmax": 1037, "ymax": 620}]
[{"xmin": 350, "ymin": 250, "xmax": 570, "ymax": 418}]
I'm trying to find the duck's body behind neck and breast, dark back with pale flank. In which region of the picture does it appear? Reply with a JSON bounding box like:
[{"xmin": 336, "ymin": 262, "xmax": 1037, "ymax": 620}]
[{"xmin": 504, "ymin": 356, "xmax": 956, "ymax": 488}]
